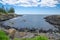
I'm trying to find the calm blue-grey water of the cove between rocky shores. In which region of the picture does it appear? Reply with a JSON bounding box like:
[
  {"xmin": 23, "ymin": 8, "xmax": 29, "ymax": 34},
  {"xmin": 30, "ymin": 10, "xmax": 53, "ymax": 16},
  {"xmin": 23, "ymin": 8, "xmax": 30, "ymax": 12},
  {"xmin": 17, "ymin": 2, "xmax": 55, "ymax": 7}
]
[{"xmin": 3, "ymin": 15, "xmax": 54, "ymax": 29}]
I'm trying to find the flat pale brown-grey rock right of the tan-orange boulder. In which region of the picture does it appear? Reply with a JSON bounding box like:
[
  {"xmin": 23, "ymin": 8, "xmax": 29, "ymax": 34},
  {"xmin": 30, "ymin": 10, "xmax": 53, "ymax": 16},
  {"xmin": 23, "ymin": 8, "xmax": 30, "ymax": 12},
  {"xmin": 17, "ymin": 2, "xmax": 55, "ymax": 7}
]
[{"xmin": 15, "ymin": 31, "xmax": 35, "ymax": 38}]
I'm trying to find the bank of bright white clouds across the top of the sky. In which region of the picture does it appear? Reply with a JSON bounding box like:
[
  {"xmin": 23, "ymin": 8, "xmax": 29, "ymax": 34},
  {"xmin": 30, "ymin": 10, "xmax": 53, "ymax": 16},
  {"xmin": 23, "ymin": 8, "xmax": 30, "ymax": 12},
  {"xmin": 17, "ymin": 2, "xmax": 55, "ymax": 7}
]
[{"xmin": 0, "ymin": 0, "xmax": 60, "ymax": 7}]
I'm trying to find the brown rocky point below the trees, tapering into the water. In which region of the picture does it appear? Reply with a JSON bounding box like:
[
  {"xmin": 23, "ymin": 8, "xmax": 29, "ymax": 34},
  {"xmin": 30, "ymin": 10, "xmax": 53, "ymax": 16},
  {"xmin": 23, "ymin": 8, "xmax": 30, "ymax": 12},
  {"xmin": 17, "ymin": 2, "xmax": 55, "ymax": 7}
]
[{"xmin": 0, "ymin": 13, "xmax": 22, "ymax": 22}]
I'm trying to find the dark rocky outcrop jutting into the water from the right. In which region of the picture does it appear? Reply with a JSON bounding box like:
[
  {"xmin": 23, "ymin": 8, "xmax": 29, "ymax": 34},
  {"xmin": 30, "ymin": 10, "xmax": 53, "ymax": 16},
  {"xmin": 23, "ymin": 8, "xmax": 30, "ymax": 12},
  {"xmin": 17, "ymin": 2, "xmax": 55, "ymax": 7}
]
[{"xmin": 44, "ymin": 15, "xmax": 60, "ymax": 25}]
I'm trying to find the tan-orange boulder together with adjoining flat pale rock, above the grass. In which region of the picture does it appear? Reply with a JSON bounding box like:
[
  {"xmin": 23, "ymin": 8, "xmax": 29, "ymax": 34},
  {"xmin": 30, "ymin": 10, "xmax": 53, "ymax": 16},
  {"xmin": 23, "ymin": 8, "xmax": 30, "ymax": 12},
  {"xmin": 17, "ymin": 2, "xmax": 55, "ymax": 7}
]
[{"xmin": 4, "ymin": 28, "xmax": 35, "ymax": 38}]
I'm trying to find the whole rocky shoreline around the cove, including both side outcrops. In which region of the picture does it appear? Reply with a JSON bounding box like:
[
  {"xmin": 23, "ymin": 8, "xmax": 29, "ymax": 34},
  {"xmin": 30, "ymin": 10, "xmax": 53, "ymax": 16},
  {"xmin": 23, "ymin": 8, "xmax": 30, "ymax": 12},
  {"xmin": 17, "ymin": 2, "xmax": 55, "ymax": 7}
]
[{"xmin": 0, "ymin": 14, "xmax": 60, "ymax": 40}]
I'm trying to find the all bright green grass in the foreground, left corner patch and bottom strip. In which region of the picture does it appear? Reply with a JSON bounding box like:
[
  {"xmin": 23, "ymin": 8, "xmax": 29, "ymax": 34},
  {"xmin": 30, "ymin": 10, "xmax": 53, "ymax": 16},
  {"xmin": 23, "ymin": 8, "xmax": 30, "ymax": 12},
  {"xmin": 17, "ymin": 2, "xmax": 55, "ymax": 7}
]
[{"xmin": 0, "ymin": 30, "xmax": 48, "ymax": 40}]
